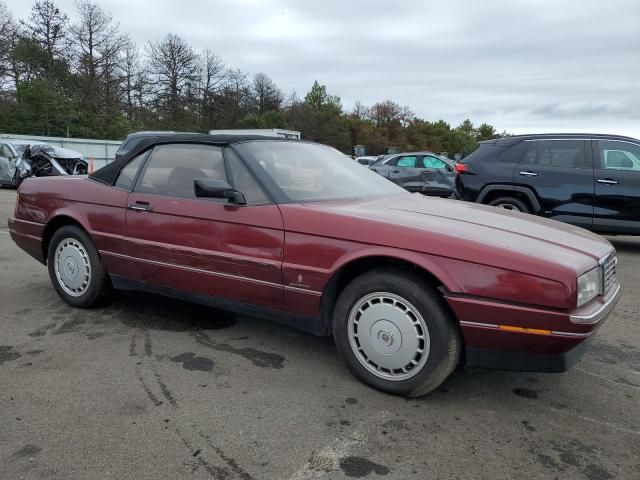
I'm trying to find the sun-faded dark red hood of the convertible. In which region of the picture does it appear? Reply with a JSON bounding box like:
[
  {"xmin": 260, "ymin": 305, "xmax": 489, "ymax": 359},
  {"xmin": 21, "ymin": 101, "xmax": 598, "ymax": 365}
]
[{"xmin": 307, "ymin": 194, "xmax": 613, "ymax": 274}]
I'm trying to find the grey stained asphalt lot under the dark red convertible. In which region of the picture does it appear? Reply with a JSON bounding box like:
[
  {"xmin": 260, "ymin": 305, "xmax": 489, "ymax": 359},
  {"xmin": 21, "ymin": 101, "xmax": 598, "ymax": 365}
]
[{"xmin": 0, "ymin": 189, "xmax": 640, "ymax": 480}]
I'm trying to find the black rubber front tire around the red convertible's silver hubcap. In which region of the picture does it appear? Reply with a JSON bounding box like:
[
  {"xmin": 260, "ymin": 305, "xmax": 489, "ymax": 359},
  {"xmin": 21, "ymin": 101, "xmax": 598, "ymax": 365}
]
[{"xmin": 333, "ymin": 267, "xmax": 462, "ymax": 397}]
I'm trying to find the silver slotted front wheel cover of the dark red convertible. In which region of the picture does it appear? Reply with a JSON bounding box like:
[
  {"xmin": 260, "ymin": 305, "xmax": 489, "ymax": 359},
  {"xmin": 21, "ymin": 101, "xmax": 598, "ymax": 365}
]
[{"xmin": 347, "ymin": 292, "xmax": 430, "ymax": 381}]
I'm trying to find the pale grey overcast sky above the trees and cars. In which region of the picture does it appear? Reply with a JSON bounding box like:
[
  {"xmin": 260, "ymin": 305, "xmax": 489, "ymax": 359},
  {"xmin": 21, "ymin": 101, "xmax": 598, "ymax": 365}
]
[{"xmin": 5, "ymin": 0, "xmax": 640, "ymax": 137}]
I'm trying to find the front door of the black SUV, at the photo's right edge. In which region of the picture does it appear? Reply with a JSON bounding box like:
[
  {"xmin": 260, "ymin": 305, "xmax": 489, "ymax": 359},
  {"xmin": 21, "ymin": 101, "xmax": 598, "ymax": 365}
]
[{"xmin": 593, "ymin": 140, "xmax": 640, "ymax": 233}]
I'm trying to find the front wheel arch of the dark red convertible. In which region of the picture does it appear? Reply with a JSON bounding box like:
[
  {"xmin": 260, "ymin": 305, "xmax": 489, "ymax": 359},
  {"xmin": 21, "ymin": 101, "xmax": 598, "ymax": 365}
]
[{"xmin": 320, "ymin": 252, "xmax": 460, "ymax": 335}]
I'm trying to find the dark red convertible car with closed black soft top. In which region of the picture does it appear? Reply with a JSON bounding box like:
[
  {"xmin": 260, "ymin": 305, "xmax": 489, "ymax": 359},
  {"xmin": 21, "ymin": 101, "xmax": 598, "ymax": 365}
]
[{"xmin": 9, "ymin": 135, "xmax": 620, "ymax": 396}]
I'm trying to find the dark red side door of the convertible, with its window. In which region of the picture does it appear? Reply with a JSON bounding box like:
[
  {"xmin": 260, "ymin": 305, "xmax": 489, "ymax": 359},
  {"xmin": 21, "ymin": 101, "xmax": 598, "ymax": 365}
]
[{"xmin": 125, "ymin": 144, "xmax": 284, "ymax": 308}]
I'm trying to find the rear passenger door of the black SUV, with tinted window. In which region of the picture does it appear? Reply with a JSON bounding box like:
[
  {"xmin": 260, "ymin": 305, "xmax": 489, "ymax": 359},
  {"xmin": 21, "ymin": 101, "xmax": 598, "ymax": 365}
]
[{"xmin": 514, "ymin": 139, "xmax": 594, "ymax": 228}]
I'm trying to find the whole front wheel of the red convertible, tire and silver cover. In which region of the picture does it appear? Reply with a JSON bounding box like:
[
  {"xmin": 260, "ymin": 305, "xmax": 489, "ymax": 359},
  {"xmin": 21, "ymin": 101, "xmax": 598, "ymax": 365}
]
[{"xmin": 333, "ymin": 268, "xmax": 462, "ymax": 397}]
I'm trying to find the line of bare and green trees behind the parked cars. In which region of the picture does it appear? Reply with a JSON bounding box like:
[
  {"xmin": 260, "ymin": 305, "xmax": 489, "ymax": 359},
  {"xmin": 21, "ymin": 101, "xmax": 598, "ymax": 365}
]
[{"xmin": 0, "ymin": 0, "xmax": 504, "ymax": 155}]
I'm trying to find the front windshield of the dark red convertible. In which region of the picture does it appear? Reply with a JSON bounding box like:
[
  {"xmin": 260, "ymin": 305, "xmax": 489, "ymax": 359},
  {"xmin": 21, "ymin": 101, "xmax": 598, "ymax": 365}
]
[{"xmin": 238, "ymin": 140, "xmax": 407, "ymax": 202}]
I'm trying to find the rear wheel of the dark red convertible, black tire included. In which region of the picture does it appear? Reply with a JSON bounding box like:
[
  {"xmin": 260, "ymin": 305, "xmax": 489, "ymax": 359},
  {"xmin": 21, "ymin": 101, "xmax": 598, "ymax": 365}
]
[{"xmin": 47, "ymin": 225, "xmax": 111, "ymax": 308}]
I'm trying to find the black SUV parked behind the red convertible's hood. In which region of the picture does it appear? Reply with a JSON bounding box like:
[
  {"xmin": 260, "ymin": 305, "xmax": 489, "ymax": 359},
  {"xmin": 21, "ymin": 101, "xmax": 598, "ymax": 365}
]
[{"xmin": 453, "ymin": 134, "xmax": 640, "ymax": 235}]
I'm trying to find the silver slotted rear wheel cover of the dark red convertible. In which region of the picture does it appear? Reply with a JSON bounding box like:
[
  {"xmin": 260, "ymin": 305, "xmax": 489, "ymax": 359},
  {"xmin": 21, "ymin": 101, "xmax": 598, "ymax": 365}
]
[{"xmin": 54, "ymin": 237, "xmax": 91, "ymax": 297}]
